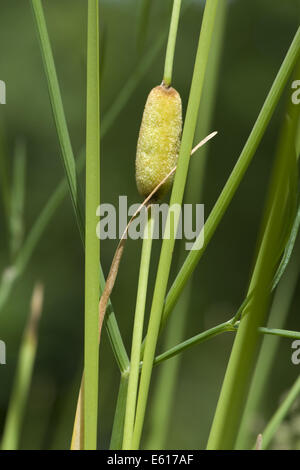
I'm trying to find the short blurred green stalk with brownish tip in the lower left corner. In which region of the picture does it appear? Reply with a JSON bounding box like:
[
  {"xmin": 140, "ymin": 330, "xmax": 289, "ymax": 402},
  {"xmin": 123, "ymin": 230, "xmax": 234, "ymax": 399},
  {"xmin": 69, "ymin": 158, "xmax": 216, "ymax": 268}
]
[{"xmin": 1, "ymin": 284, "xmax": 44, "ymax": 450}]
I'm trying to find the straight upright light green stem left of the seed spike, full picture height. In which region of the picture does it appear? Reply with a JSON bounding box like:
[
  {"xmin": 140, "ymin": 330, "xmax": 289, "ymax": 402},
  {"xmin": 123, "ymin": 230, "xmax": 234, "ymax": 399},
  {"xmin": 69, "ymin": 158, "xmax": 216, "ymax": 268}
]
[{"xmin": 84, "ymin": 0, "xmax": 100, "ymax": 450}]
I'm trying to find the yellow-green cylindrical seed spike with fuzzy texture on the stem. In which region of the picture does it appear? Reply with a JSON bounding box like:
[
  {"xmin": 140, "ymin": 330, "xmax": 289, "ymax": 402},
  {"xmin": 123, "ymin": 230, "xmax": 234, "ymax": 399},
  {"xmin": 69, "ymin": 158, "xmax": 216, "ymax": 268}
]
[{"xmin": 136, "ymin": 85, "xmax": 182, "ymax": 199}]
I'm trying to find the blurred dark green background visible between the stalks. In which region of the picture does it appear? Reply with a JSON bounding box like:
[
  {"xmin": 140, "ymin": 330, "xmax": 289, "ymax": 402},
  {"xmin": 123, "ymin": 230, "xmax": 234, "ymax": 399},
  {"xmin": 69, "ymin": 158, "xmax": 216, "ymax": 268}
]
[{"xmin": 0, "ymin": 0, "xmax": 300, "ymax": 449}]
